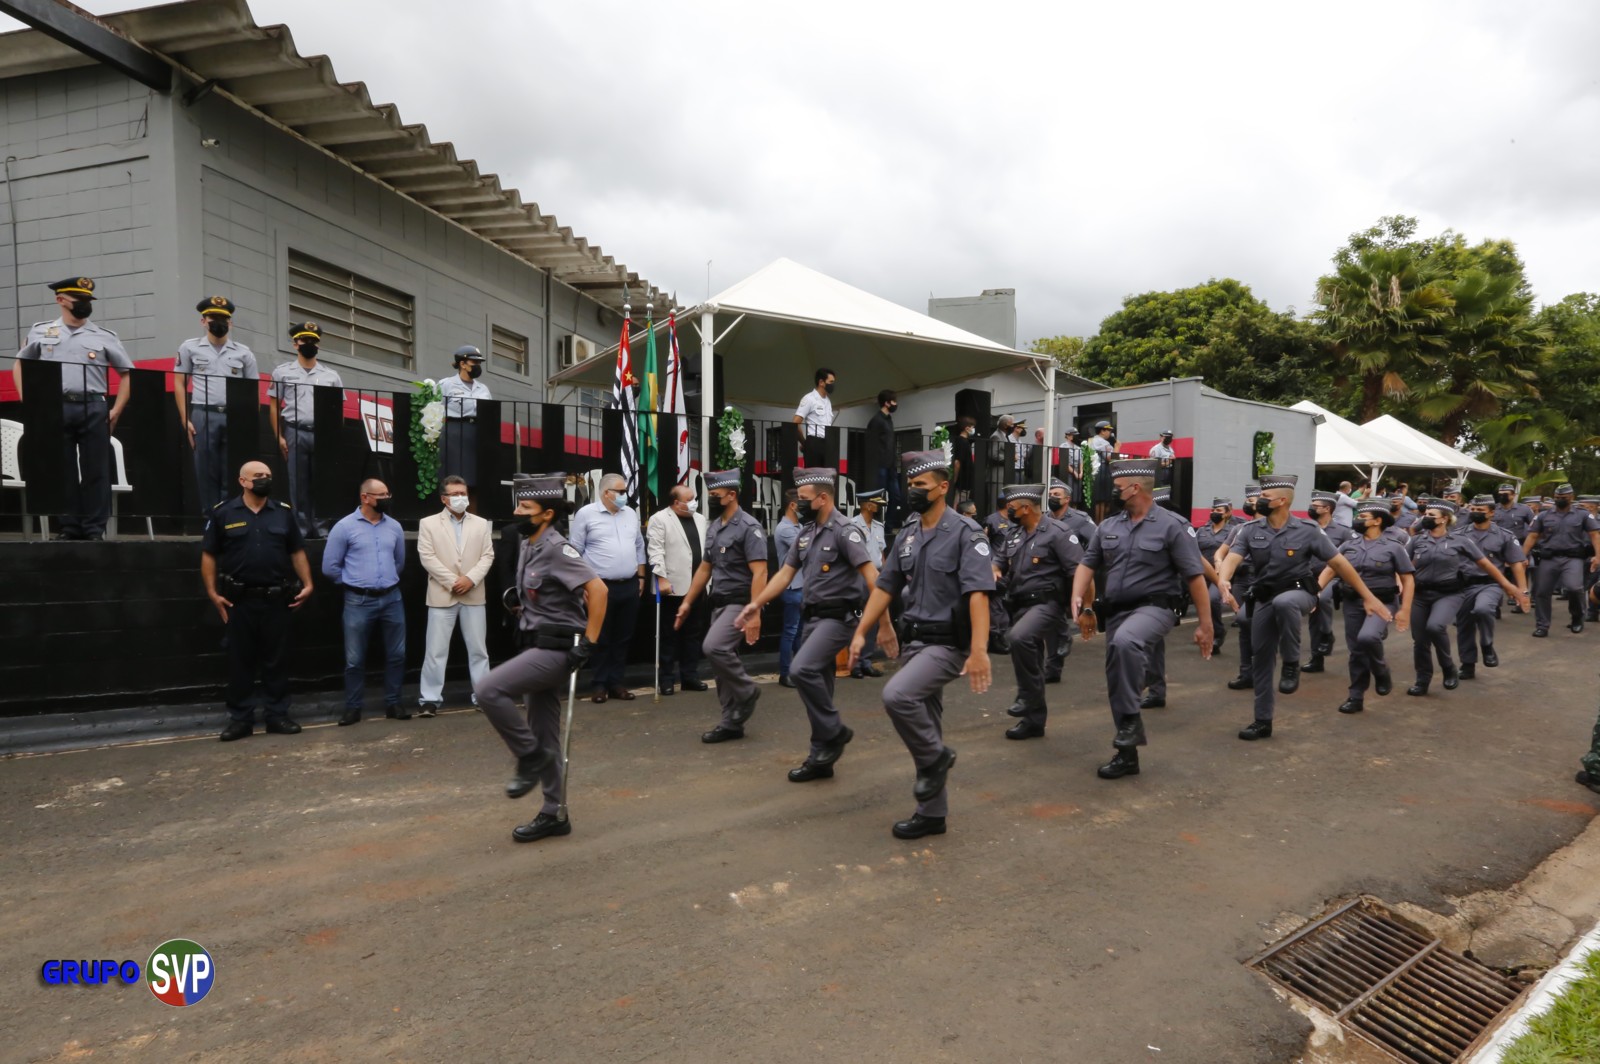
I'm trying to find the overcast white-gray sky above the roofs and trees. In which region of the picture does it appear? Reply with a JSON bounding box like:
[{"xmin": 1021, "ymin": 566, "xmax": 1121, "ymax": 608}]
[{"xmin": 6, "ymin": 0, "xmax": 1600, "ymax": 346}]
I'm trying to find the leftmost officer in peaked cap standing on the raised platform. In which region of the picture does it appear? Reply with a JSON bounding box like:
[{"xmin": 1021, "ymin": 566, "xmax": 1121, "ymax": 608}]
[{"xmin": 11, "ymin": 277, "xmax": 133, "ymax": 539}]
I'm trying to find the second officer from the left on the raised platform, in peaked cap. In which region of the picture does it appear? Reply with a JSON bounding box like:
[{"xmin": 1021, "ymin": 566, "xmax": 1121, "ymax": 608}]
[{"xmin": 173, "ymin": 296, "xmax": 261, "ymax": 514}]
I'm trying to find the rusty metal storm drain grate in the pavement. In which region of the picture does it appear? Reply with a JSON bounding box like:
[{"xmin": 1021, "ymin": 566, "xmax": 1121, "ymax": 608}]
[{"xmin": 1246, "ymin": 899, "xmax": 1522, "ymax": 1064}]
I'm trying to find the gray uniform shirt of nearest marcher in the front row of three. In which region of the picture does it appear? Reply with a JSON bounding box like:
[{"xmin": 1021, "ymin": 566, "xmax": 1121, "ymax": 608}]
[{"xmin": 883, "ymin": 509, "xmax": 992, "ymax": 624}]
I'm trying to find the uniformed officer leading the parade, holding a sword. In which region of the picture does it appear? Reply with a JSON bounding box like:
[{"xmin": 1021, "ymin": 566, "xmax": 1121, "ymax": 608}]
[{"xmin": 474, "ymin": 474, "xmax": 606, "ymax": 842}]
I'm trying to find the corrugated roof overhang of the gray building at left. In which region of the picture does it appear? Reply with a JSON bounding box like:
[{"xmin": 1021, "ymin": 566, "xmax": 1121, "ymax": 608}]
[{"xmin": 0, "ymin": 0, "xmax": 669, "ymax": 307}]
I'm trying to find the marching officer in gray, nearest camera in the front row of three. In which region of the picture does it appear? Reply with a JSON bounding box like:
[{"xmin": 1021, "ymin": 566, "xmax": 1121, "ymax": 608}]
[{"xmin": 851, "ymin": 451, "xmax": 985, "ymax": 838}]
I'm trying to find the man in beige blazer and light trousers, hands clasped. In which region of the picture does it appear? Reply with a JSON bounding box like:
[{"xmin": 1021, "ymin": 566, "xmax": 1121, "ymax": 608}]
[{"xmin": 416, "ymin": 477, "xmax": 494, "ymax": 717}]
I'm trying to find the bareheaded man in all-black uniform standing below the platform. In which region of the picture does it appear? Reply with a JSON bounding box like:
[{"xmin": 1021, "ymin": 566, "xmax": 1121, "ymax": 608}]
[{"xmin": 200, "ymin": 462, "xmax": 310, "ymax": 742}]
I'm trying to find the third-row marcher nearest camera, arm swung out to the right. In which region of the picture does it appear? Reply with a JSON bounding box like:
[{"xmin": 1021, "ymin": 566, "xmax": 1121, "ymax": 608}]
[{"xmin": 1221, "ymin": 474, "xmax": 1392, "ymax": 742}]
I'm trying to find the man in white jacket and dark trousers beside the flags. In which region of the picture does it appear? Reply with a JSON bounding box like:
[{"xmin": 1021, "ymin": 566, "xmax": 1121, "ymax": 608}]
[{"xmin": 645, "ymin": 485, "xmax": 710, "ymax": 694}]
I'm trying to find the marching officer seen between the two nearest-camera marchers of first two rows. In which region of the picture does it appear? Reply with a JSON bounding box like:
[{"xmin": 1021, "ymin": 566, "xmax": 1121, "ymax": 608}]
[{"xmin": 995, "ymin": 483, "xmax": 1083, "ymax": 739}]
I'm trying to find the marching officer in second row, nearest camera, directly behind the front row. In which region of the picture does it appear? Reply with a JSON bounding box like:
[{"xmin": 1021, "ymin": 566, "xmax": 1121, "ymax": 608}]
[{"xmin": 1072, "ymin": 459, "xmax": 1213, "ymax": 779}]
